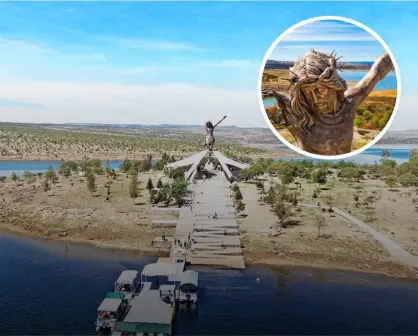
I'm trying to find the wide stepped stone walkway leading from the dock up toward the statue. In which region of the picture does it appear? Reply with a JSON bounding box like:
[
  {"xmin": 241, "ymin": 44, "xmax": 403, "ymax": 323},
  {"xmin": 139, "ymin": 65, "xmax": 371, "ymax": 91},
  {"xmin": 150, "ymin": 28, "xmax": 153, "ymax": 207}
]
[{"xmin": 172, "ymin": 172, "xmax": 245, "ymax": 269}]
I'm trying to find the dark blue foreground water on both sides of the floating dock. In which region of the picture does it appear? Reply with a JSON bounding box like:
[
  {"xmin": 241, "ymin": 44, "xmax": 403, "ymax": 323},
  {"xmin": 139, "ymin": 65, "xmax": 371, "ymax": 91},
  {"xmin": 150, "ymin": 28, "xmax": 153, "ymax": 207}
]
[{"xmin": 0, "ymin": 234, "xmax": 418, "ymax": 335}]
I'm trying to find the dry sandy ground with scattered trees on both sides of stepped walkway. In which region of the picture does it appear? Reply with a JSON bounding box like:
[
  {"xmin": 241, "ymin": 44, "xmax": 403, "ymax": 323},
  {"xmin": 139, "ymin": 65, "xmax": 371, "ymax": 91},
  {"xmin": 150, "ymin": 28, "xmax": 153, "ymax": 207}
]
[{"xmin": 0, "ymin": 131, "xmax": 418, "ymax": 276}]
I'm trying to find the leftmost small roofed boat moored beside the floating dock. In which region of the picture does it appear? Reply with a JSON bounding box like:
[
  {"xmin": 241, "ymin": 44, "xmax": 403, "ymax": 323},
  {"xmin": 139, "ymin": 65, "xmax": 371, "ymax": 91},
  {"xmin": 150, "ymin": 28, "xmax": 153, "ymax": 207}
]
[{"xmin": 96, "ymin": 292, "xmax": 126, "ymax": 333}]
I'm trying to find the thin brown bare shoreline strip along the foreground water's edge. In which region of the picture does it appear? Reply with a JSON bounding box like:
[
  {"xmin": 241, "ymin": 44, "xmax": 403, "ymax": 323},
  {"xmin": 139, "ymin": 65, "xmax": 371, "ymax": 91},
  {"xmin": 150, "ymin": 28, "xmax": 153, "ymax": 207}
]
[{"xmin": 0, "ymin": 225, "xmax": 418, "ymax": 280}]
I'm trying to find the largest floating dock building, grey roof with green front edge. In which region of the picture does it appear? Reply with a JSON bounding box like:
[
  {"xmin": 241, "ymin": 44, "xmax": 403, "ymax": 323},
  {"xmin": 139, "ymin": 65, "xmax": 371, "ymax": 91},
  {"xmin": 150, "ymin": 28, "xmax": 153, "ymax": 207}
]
[{"xmin": 114, "ymin": 290, "xmax": 175, "ymax": 336}]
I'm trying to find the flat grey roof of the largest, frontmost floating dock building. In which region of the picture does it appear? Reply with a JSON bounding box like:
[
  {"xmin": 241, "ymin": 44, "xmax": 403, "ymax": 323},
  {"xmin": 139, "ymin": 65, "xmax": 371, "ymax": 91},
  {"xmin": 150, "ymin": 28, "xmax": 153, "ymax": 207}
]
[{"xmin": 123, "ymin": 290, "xmax": 174, "ymax": 324}]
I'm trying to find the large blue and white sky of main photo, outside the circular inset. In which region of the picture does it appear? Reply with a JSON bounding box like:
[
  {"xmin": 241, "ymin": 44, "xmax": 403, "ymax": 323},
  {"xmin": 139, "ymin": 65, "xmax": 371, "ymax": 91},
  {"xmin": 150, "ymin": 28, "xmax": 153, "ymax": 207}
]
[{"xmin": 0, "ymin": 2, "xmax": 418, "ymax": 130}]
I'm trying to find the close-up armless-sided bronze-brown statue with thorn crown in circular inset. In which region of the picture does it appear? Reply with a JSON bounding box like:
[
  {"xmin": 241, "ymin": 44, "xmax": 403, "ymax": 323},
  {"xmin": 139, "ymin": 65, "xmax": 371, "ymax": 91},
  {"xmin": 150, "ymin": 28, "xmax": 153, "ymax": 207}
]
[{"xmin": 269, "ymin": 50, "xmax": 393, "ymax": 155}]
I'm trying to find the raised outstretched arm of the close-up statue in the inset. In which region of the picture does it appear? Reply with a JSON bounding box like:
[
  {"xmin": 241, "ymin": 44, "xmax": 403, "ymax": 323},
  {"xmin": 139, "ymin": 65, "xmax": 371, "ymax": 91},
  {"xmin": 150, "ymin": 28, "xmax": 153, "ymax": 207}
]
[{"xmin": 345, "ymin": 52, "xmax": 393, "ymax": 106}]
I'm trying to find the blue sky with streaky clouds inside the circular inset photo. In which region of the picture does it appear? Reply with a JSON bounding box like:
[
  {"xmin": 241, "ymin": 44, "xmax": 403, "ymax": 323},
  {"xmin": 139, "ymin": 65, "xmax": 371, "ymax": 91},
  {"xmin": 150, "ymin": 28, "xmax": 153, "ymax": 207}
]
[{"xmin": 269, "ymin": 20, "xmax": 385, "ymax": 62}]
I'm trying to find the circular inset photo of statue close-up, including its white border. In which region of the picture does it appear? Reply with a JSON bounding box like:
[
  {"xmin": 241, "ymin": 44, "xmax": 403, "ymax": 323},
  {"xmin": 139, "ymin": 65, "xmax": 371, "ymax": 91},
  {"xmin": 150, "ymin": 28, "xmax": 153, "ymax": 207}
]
[{"xmin": 259, "ymin": 16, "xmax": 401, "ymax": 159}]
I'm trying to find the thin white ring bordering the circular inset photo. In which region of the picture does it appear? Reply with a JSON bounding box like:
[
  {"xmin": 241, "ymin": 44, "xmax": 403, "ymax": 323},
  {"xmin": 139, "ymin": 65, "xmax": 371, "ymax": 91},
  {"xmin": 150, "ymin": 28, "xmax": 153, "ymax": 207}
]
[{"xmin": 258, "ymin": 16, "xmax": 401, "ymax": 160}]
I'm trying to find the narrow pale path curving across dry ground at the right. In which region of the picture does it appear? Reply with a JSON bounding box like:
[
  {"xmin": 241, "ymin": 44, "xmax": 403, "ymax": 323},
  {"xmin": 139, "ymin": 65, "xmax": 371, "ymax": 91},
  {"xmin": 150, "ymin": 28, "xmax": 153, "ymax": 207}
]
[{"xmin": 299, "ymin": 203, "xmax": 418, "ymax": 270}]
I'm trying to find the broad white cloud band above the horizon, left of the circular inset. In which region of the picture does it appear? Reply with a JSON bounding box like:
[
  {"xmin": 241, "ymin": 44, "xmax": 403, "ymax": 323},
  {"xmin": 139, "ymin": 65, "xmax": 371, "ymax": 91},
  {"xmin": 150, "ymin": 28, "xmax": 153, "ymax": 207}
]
[{"xmin": 0, "ymin": 81, "xmax": 266, "ymax": 127}]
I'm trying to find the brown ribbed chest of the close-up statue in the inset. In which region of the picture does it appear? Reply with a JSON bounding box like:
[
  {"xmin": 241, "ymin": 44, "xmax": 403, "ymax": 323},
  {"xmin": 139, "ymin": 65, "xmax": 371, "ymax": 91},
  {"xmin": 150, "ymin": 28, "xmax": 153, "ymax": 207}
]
[{"xmin": 301, "ymin": 104, "xmax": 354, "ymax": 155}]
